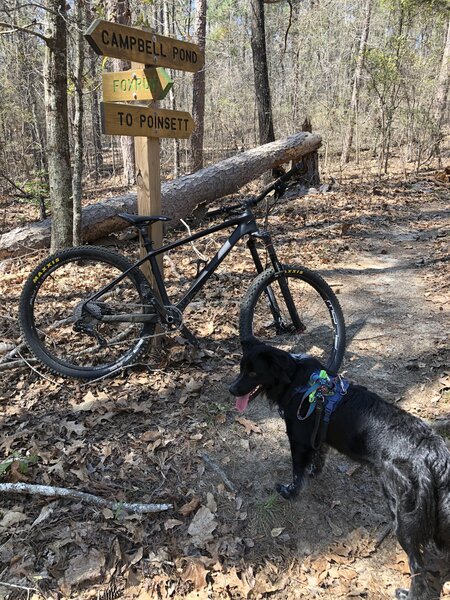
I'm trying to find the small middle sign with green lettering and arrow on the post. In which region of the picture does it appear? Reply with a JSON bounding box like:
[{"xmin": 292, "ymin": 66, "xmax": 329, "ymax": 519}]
[{"xmin": 102, "ymin": 67, "xmax": 173, "ymax": 102}]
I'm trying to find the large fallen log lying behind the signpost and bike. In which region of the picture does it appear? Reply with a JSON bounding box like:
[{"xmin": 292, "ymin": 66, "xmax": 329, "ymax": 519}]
[{"xmin": 0, "ymin": 132, "xmax": 321, "ymax": 259}]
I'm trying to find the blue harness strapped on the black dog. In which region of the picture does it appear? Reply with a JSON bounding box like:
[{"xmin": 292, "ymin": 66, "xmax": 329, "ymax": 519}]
[{"xmin": 292, "ymin": 369, "xmax": 349, "ymax": 450}]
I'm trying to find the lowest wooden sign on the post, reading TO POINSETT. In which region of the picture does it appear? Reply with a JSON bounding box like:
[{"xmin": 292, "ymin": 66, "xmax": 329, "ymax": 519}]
[{"xmin": 101, "ymin": 102, "xmax": 195, "ymax": 138}]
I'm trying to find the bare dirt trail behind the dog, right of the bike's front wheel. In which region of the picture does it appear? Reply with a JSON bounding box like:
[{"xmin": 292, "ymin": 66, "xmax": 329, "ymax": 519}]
[{"xmin": 338, "ymin": 195, "xmax": 450, "ymax": 396}]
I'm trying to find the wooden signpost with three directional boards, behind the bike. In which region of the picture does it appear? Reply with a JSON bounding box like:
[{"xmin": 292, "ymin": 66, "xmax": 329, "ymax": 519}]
[{"xmin": 85, "ymin": 19, "xmax": 205, "ymax": 288}]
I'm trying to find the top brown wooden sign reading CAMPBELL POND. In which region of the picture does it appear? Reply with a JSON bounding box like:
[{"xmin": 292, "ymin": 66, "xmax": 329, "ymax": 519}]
[{"xmin": 84, "ymin": 19, "xmax": 205, "ymax": 73}]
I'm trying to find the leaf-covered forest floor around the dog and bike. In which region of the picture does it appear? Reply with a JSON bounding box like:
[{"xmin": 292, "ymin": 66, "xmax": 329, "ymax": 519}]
[{"xmin": 0, "ymin": 161, "xmax": 450, "ymax": 600}]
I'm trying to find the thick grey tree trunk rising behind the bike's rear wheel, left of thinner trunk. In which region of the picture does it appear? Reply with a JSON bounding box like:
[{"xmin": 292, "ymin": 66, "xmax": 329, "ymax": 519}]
[{"xmin": 44, "ymin": 0, "xmax": 73, "ymax": 251}]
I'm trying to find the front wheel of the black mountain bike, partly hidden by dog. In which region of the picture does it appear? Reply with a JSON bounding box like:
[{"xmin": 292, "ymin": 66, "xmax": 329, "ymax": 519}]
[{"xmin": 239, "ymin": 265, "xmax": 345, "ymax": 371}]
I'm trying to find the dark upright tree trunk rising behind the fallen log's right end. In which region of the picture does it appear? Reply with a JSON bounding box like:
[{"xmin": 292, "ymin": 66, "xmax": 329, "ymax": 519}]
[{"xmin": 250, "ymin": 0, "xmax": 275, "ymax": 144}]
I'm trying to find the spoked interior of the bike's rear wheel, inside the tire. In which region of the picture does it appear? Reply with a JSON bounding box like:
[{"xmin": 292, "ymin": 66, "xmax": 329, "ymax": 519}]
[{"xmin": 25, "ymin": 253, "xmax": 150, "ymax": 367}]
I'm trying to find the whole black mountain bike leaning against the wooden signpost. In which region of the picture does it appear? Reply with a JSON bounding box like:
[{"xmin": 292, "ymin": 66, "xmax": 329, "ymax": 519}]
[{"xmin": 19, "ymin": 167, "xmax": 345, "ymax": 379}]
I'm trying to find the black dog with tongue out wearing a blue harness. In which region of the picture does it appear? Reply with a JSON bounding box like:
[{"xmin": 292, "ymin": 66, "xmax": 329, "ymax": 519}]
[{"xmin": 230, "ymin": 338, "xmax": 450, "ymax": 600}]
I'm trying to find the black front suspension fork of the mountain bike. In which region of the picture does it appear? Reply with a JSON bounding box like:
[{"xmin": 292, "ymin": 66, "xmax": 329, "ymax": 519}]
[{"xmin": 247, "ymin": 231, "xmax": 306, "ymax": 333}]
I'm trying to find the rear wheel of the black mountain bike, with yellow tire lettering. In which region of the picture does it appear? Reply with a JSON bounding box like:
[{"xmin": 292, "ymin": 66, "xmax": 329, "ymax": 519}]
[{"xmin": 19, "ymin": 246, "xmax": 155, "ymax": 379}]
